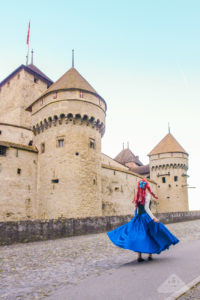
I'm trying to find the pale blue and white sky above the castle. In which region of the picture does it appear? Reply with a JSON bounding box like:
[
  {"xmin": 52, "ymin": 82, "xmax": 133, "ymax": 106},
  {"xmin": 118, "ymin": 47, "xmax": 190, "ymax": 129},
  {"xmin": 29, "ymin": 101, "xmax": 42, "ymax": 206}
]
[{"xmin": 0, "ymin": 0, "xmax": 200, "ymax": 210}]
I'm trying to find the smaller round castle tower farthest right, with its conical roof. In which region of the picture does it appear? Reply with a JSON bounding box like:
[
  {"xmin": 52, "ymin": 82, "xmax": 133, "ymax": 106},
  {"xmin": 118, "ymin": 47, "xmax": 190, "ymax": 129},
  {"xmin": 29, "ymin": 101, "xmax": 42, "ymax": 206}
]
[{"xmin": 148, "ymin": 133, "xmax": 189, "ymax": 212}]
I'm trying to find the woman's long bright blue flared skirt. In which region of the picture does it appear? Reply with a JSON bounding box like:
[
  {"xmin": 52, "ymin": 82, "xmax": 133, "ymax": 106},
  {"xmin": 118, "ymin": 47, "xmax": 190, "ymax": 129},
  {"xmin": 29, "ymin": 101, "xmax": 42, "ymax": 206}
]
[{"xmin": 107, "ymin": 212, "xmax": 179, "ymax": 254}]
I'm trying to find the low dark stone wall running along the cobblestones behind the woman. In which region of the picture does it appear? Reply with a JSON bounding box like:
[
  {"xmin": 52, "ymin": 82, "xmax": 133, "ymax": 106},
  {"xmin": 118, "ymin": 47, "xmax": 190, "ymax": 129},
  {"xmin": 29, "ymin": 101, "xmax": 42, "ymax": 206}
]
[{"xmin": 0, "ymin": 210, "xmax": 200, "ymax": 245}]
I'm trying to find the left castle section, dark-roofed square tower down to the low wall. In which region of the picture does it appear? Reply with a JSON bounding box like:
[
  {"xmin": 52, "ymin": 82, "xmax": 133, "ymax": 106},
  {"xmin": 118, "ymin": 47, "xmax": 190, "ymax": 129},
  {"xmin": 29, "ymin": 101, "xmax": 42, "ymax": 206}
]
[{"xmin": 0, "ymin": 64, "xmax": 53, "ymax": 221}]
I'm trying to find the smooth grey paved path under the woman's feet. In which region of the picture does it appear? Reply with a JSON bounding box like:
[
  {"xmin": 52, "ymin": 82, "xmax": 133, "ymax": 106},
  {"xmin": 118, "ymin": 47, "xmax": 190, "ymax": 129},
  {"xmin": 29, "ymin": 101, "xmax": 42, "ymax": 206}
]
[{"xmin": 47, "ymin": 240, "xmax": 200, "ymax": 300}]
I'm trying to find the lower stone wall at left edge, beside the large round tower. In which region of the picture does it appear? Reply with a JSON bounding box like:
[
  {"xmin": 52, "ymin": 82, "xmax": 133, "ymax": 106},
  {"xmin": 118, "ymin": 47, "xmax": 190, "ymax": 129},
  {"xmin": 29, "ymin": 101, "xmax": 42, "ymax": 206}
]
[{"xmin": 0, "ymin": 147, "xmax": 38, "ymax": 221}]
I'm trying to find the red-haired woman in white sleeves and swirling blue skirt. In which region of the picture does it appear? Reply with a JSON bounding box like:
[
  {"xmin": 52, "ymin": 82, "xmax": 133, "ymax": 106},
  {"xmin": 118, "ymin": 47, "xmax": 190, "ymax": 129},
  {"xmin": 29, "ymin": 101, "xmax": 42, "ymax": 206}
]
[{"xmin": 107, "ymin": 179, "xmax": 179, "ymax": 262}]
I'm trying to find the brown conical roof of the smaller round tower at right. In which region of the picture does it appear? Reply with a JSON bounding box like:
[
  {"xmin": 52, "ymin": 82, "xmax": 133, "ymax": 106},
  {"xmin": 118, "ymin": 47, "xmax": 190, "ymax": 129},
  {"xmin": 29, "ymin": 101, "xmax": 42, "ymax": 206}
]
[{"xmin": 148, "ymin": 133, "xmax": 187, "ymax": 156}]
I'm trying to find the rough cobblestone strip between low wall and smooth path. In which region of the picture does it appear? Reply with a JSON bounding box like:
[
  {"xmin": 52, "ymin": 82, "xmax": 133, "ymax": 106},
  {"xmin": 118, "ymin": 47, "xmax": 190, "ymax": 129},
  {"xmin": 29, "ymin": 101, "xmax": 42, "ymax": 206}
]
[{"xmin": 0, "ymin": 220, "xmax": 200, "ymax": 300}]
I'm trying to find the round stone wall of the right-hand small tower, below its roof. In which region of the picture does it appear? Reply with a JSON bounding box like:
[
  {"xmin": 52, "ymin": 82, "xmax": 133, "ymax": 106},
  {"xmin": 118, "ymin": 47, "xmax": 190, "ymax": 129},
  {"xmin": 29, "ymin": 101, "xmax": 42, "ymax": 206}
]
[{"xmin": 150, "ymin": 153, "xmax": 189, "ymax": 212}]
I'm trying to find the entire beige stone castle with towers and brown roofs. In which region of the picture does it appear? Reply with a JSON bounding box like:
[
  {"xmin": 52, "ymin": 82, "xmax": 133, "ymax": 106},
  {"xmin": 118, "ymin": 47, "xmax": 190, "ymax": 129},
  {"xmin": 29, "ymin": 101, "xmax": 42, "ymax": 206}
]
[{"xmin": 0, "ymin": 63, "xmax": 188, "ymax": 222}]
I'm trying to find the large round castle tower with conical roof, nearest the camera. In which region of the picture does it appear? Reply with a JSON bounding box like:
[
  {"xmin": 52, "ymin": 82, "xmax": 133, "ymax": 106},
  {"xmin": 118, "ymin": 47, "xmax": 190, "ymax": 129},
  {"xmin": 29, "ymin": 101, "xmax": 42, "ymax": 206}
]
[{"xmin": 27, "ymin": 67, "xmax": 106, "ymax": 219}]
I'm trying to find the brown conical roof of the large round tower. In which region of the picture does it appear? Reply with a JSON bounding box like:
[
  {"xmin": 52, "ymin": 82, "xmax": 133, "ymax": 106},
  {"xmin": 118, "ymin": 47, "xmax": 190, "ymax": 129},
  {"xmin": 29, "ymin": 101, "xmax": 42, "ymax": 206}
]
[{"xmin": 42, "ymin": 68, "xmax": 102, "ymax": 98}]
